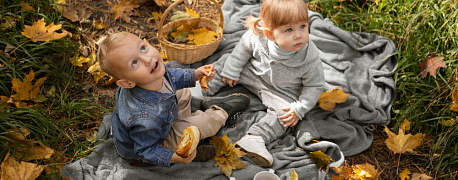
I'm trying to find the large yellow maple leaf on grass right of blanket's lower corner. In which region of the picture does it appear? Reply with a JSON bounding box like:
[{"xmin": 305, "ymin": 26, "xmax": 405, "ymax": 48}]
[{"xmin": 385, "ymin": 126, "xmax": 425, "ymax": 153}]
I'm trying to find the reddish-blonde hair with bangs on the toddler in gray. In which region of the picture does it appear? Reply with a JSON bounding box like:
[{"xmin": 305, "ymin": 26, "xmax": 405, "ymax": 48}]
[{"xmin": 245, "ymin": 0, "xmax": 309, "ymax": 36}]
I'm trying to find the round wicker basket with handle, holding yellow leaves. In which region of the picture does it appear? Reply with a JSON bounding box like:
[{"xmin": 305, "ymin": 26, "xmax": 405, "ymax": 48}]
[{"xmin": 157, "ymin": 0, "xmax": 224, "ymax": 64}]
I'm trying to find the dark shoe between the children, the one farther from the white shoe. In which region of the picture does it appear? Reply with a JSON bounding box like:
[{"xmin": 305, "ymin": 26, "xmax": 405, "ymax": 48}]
[{"xmin": 200, "ymin": 93, "xmax": 250, "ymax": 116}]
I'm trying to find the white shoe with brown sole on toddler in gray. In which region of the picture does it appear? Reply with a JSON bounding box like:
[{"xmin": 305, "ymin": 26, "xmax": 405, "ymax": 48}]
[{"xmin": 236, "ymin": 135, "xmax": 274, "ymax": 167}]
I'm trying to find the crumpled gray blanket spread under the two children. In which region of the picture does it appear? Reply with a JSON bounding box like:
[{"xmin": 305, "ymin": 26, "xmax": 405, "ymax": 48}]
[{"xmin": 61, "ymin": 0, "xmax": 398, "ymax": 180}]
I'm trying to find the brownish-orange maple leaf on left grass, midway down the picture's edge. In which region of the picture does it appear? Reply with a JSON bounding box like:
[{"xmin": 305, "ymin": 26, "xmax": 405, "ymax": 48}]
[{"xmin": 11, "ymin": 70, "xmax": 46, "ymax": 101}]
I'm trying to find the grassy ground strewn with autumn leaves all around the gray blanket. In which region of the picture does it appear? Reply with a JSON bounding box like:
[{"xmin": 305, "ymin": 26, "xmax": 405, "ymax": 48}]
[{"xmin": 0, "ymin": 0, "xmax": 458, "ymax": 179}]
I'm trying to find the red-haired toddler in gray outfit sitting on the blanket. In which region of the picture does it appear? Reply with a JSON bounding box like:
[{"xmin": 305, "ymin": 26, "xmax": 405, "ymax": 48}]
[{"xmin": 206, "ymin": 0, "xmax": 324, "ymax": 167}]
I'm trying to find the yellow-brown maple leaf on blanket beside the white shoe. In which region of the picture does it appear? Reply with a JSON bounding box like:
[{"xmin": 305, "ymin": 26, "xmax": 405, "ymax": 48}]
[{"xmin": 210, "ymin": 134, "xmax": 246, "ymax": 177}]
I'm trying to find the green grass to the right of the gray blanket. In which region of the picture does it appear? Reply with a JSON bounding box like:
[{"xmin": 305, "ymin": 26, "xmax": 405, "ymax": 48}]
[{"xmin": 310, "ymin": 0, "xmax": 458, "ymax": 179}]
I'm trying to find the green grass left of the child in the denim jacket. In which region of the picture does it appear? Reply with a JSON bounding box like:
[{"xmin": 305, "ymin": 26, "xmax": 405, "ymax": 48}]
[{"xmin": 0, "ymin": 0, "xmax": 108, "ymax": 179}]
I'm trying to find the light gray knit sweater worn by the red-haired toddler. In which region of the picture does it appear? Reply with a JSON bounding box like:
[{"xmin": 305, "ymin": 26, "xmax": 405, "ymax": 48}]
[{"xmin": 221, "ymin": 31, "xmax": 324, "ymax": 119}]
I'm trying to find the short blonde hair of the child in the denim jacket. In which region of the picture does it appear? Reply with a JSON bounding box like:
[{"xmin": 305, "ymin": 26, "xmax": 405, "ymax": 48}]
[{"xmin": 97, "ymin": 32, "xmax": 131, "ymax": 78}]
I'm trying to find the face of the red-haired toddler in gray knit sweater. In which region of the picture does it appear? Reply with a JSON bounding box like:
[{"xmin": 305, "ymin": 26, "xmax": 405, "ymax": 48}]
[{"xmin": 272, "ymin": 22, "xmax": 309, "ymax": 51}]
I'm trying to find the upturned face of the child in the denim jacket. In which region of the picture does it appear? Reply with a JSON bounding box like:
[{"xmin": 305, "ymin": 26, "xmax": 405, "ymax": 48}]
[{"xmin": 107, "ymin": 34, "xmax": 165, "ymax": 90}]
